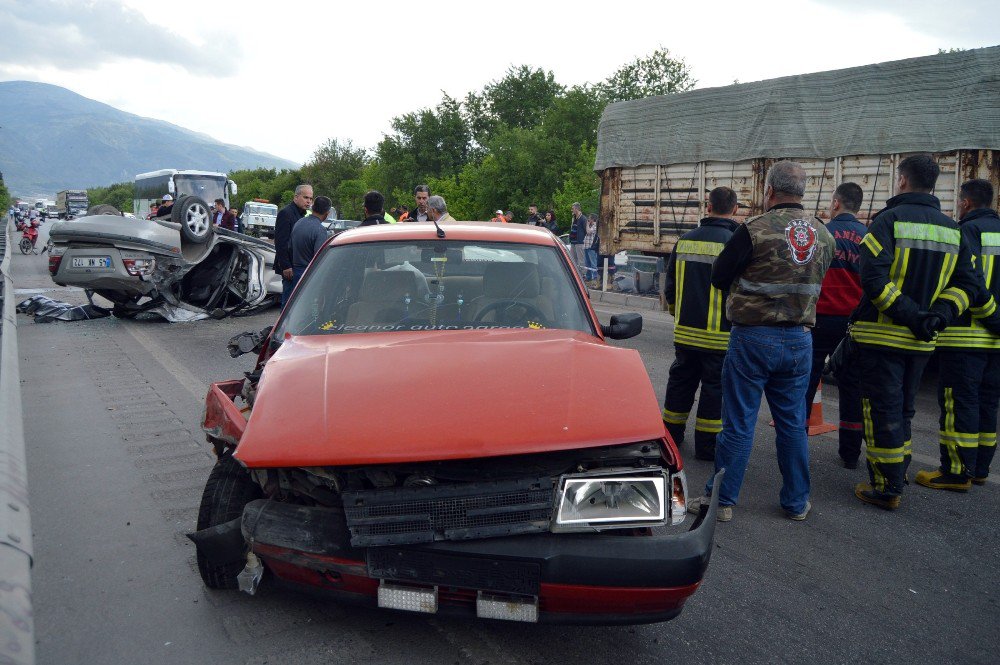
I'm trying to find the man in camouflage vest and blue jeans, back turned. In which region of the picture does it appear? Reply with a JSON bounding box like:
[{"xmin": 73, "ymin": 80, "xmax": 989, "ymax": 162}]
[{"xmin": 690, "ymin": 161, "xmax": 835, "ymax": 522}]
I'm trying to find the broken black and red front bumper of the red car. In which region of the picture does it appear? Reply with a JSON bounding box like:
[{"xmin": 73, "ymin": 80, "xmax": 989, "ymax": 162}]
[{"xmin": 207, "ymin": 472, "xmax": 718, "ymax": 624}]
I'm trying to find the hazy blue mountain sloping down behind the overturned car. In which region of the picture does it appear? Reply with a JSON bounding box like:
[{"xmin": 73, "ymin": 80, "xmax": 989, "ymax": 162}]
[{"xmin": 0, "ymin": 81, "xmax": 299, "ymax": 198}]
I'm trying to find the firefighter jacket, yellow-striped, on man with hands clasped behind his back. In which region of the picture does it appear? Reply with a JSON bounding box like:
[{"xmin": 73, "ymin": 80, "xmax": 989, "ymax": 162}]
[{"xmin": 851, "ymin": 192, "xmax": 975, "ymax": 353}]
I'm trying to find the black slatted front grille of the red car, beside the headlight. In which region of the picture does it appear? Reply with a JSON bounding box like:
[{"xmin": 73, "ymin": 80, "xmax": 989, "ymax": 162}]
[{"xmin": 343, "ymin": 478, "xmax": 554, "ymax": 547}]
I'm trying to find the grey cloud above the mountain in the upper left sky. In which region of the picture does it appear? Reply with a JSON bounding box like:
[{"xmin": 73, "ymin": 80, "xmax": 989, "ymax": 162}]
[{"xmin": 0, "ymin": 0, "xmax": 240, "ymax": 77}]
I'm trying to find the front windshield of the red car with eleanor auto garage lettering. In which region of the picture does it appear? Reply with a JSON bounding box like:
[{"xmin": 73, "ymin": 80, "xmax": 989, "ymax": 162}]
[{"xmin": 275, "ymin": 240, "xmax": 594, "ymax": 339}]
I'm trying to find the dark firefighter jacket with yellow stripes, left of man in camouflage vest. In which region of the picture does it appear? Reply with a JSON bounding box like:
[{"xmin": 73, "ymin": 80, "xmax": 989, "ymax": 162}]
[{"xmin": 664, "ymin": 217, "xmax": 739, "ymax": 353}]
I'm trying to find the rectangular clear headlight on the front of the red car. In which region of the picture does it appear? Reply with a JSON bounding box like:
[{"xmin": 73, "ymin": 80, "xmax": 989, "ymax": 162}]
[{"xmin": 552, "ymin": 471, "xmax": 673, "ymax": 531}]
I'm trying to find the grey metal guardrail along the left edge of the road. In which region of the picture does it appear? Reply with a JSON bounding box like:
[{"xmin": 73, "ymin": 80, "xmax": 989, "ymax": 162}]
[{"xmin": 0, "ymin": 216, "xmax": 35, "ymax": 665}]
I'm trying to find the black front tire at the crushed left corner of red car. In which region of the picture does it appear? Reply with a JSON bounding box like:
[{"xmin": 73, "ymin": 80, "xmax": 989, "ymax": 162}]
[{"xmin": 198, "ymin": 454, "xmax": 263, "ymax": 589}]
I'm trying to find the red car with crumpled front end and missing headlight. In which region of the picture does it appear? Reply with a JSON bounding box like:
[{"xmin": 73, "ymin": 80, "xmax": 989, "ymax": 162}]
[{"xmin": 191, "ymin": 223, "xmax": 717, "ymax": 623}]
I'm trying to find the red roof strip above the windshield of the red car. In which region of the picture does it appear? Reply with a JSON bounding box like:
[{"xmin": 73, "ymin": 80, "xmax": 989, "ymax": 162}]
[{"xmin": 331, "ymin": 222, "xmax": 559, "ymax": 246}]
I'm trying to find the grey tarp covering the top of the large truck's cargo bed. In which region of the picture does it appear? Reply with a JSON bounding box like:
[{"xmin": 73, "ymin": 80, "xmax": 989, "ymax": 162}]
[{"xmin": 594, "ymin": 46, "xmax": 1000, "ymax": 171}]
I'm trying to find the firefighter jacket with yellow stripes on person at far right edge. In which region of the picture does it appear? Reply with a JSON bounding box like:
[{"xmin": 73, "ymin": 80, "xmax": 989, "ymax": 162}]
[{"xmin": 937, "ymin": 208, "xmax": 1000, "ymax": 353}]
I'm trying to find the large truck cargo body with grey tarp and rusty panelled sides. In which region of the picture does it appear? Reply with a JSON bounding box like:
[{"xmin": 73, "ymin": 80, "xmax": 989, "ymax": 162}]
[{"xmin": 594, "ymin": 46, "xmax": 1000, "ymax": 268}]
